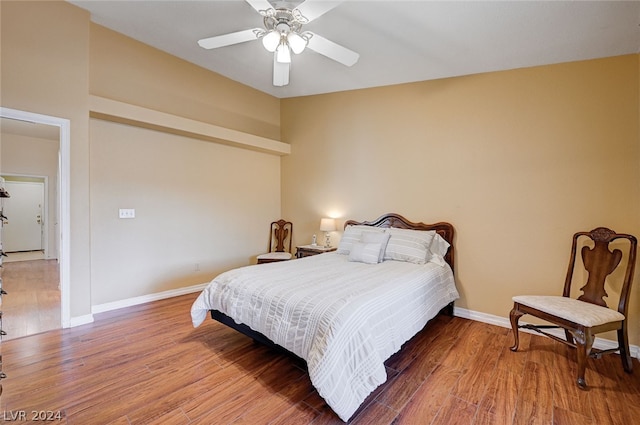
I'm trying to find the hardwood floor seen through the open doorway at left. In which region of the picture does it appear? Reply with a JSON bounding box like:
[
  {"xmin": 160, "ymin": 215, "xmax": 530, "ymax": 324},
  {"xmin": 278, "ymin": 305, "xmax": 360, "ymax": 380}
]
[{"xmin": 2, "ymin": 253, "xmax": 61, "ymax": 341}]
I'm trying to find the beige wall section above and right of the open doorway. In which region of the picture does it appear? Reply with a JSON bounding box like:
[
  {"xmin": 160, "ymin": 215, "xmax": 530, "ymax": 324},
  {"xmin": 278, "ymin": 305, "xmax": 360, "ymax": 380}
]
[{"xmin": 0, "ymin": 1, "xmax": 91, "ymax": 317}]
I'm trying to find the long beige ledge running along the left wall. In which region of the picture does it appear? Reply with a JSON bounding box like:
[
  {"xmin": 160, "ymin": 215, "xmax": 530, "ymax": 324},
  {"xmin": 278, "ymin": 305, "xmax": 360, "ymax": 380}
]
[{"xmin": 89, "ymin": 96, "xmax": 291, "ymax": 155}]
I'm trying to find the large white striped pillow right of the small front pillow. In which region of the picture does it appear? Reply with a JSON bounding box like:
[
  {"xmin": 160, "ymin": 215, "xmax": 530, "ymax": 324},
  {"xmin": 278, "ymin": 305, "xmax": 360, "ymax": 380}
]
[{"xmin": 384, "ymin": 228, "xmax": 436, "ymax": 264}]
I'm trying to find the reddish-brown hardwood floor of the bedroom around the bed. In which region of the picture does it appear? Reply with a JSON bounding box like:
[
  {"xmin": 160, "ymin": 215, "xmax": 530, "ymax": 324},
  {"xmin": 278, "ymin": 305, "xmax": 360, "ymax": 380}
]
[{"xmin": 0, "ymin": 294, "xmax": 640, "ymax": 425}]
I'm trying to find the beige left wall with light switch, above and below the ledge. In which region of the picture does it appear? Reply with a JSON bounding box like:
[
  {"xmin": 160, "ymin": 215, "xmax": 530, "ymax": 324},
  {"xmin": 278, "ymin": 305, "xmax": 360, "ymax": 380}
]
[{"xmin": 89, "ymin": 24, "xmax": 281, "ymax": 305}]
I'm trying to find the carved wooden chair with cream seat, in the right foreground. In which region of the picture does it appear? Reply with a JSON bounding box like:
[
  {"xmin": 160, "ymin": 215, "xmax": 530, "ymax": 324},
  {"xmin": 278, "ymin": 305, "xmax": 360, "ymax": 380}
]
[{"xmin": 509, "ymin": 227, "xmax": 637, "ymax": 389}]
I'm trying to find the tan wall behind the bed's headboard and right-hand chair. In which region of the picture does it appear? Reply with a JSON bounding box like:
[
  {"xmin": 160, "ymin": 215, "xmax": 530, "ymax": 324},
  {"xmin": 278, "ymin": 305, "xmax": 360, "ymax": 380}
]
[{"xmin": 281, "ymin": 55, "xmax": 640, "ymax": 344}]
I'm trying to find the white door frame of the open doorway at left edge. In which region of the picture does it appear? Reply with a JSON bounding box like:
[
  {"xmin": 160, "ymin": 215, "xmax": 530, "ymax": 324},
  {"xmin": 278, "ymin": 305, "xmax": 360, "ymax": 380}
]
[{"xmin": 0, "ymin": 107, "xmax": 71, "ymax": 328}]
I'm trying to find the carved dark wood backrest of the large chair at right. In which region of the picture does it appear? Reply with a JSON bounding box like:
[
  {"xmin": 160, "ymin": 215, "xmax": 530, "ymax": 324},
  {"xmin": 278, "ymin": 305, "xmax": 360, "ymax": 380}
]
[{"xmin": 562, "ymin": 227, "xmax": 638, "ymax": 317}]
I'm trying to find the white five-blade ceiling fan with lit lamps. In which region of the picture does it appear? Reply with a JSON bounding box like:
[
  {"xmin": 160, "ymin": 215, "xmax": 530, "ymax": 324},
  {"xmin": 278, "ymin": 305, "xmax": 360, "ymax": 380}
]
[{"xmin": 198, "ymin": 0, "xmax": 360, "ymax": 86}]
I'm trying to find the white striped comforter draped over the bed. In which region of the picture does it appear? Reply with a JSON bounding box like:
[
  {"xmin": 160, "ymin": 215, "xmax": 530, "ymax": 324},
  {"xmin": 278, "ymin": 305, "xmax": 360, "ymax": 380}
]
[{"xmin": 191, "ymin": 253, "xmax": 458, "ymax": 421}]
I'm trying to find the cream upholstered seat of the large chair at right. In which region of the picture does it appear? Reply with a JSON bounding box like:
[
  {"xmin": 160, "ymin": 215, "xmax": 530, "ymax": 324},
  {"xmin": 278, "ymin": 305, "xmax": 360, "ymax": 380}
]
[{"xmin": 513, "ymin": 295, "xmax": 624, "ymax": 327}]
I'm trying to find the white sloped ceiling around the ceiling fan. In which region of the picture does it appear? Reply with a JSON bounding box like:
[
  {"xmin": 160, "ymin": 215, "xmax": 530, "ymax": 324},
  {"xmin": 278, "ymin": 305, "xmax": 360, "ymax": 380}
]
[{"xmin": 70, "ymin": 0, "xmax": 640, "ymax": 98}]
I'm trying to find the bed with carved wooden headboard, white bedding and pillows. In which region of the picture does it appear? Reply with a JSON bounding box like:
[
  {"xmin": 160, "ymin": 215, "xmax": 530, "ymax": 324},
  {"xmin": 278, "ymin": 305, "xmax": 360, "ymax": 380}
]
[{"xmin": 191, "ymin": 213, "xmax": 458, "ymax": 422}]
